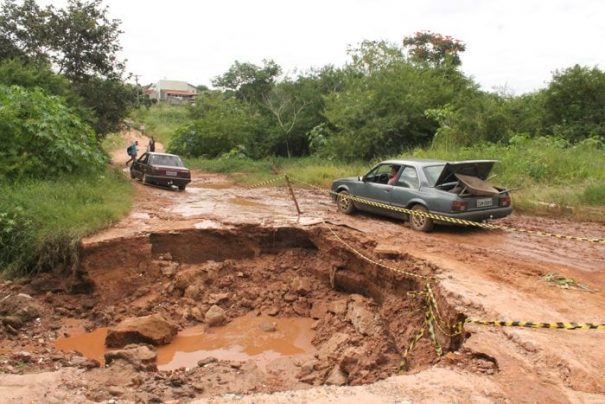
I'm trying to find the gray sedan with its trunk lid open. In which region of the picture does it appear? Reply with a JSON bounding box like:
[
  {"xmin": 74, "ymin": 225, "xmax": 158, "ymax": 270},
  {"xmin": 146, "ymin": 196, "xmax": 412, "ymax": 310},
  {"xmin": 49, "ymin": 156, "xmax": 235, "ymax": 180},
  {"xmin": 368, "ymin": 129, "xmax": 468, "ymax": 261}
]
[{"xmin": 331, "ymin": 159, "xmax": 512, "ymax": 231}]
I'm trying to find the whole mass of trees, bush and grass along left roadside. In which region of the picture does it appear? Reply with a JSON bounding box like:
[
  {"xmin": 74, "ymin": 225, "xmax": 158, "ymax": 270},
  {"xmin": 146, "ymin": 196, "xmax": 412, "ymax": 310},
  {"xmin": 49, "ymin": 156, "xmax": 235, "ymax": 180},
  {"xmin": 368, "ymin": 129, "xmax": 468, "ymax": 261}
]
[{"xmin": 0, "ymin": 0, "xmax": 140, "ymax": 276}]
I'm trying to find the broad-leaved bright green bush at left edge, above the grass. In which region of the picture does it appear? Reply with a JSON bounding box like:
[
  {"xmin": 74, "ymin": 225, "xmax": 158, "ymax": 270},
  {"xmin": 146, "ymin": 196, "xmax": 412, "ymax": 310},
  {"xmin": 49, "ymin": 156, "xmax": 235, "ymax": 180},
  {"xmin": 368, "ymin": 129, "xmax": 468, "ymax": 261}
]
[{"xmin": 0, "ymin": 85, "xmax": 105, "ymax": 179}]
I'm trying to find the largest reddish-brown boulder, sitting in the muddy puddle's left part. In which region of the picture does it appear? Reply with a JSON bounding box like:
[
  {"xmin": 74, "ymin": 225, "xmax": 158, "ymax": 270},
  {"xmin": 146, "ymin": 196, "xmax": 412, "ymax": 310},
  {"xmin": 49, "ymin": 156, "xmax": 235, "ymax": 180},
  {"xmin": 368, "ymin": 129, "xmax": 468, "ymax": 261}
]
[{"xmin": 105, "ymin": 314, "xmax": 178, "ymax": 348}]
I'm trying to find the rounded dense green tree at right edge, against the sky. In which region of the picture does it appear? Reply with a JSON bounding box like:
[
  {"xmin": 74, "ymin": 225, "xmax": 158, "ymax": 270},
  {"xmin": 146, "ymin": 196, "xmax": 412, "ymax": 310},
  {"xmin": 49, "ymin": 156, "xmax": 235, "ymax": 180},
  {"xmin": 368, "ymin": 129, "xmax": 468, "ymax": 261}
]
[{"xmin": 544, "ymin": 65, "xmax": 605, "ymax": 142}]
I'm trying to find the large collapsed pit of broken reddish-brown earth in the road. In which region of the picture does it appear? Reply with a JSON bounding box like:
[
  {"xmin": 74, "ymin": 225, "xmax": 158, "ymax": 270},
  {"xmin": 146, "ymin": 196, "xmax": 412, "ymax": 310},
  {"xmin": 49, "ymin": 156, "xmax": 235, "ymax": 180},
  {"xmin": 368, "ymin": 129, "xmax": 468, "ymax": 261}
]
[{"xmin": 2, "ymin": 225, "xmax": 463, "ymax": 399}]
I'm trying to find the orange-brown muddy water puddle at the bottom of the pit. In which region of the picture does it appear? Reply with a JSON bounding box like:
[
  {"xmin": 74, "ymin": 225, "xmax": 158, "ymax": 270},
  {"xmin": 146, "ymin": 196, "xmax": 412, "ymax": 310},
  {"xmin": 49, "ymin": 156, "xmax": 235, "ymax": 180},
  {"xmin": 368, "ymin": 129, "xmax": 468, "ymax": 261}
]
[{"xmin": 55, "ymin": 314, "xmax": 315, "ymax": 370}]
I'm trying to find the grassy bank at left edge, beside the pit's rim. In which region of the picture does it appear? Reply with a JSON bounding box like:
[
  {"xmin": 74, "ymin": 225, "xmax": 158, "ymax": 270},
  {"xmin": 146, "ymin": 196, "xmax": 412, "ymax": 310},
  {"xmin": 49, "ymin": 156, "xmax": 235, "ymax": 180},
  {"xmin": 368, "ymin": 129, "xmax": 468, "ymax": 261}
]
[{"xmin": 0, "ymin": 168, "xmax": 133, "ymax": 276}]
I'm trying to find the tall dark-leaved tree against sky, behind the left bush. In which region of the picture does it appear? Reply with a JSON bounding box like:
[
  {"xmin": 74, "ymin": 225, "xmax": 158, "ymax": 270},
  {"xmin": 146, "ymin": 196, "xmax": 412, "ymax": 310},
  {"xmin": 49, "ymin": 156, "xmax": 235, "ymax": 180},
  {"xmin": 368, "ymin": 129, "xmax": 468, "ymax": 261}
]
[{"xmin": 0, "ymin": 0, "xmax": 134, "ymax": 137}]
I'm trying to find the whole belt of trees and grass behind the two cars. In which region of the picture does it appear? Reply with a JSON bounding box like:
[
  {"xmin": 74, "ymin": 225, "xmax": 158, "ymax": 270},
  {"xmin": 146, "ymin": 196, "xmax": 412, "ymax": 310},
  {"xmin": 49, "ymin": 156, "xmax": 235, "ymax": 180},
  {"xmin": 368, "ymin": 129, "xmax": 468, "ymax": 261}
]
[{"xmin": 131, "ymin": 32, "xmax": 605, "ymax": 222}]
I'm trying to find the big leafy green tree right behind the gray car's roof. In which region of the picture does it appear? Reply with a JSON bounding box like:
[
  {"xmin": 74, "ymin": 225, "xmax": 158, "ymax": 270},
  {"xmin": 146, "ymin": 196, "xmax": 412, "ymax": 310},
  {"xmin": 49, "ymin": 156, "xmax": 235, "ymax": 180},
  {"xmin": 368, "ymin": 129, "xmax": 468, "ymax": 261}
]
[{"xmin": 324, "ymin": 43, "xmax": 473, "ymax": 159}]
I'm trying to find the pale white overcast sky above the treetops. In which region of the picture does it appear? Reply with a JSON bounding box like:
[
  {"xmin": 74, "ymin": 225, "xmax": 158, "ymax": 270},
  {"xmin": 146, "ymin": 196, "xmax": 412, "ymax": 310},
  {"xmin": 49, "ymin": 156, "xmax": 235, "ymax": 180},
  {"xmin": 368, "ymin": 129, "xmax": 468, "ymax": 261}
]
[{"xmin": 39, "ymin": 0, "xmax": 605, "ymax": 94}]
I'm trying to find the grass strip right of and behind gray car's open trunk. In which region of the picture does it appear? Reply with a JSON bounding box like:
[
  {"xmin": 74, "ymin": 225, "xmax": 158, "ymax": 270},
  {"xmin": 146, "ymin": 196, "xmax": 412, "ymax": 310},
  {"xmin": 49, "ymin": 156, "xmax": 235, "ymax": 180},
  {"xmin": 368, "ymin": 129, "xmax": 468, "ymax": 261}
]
[{"xmin": 408, "ymin": 137, "xmax": 605, "ymax": 222}]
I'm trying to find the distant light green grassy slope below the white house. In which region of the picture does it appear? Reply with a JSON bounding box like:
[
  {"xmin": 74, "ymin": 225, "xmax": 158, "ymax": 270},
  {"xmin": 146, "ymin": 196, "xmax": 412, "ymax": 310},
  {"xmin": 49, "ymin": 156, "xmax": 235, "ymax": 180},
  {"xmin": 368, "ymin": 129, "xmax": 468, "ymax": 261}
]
[{"xmin": 130, "ymin": 103, "xmax": 191, "ymax": 148}]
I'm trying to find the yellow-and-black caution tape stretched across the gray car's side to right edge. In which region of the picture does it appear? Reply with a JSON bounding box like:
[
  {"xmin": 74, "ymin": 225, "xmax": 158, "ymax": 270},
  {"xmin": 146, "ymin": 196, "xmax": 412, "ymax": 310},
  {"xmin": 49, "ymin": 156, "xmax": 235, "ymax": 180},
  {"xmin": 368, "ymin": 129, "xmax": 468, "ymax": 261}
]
[{"xmin": 330, "ymin": 191, "xmax": 605, "ymax": 245}]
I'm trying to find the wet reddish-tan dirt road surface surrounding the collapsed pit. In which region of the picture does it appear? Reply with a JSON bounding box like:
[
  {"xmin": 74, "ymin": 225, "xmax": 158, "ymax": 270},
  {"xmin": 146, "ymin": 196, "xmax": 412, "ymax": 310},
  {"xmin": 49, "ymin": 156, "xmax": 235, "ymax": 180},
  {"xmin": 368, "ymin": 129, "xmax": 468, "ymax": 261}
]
[{"xmin": 0, "ymin": 132, "xmax": 605, "ymax": 403}]
